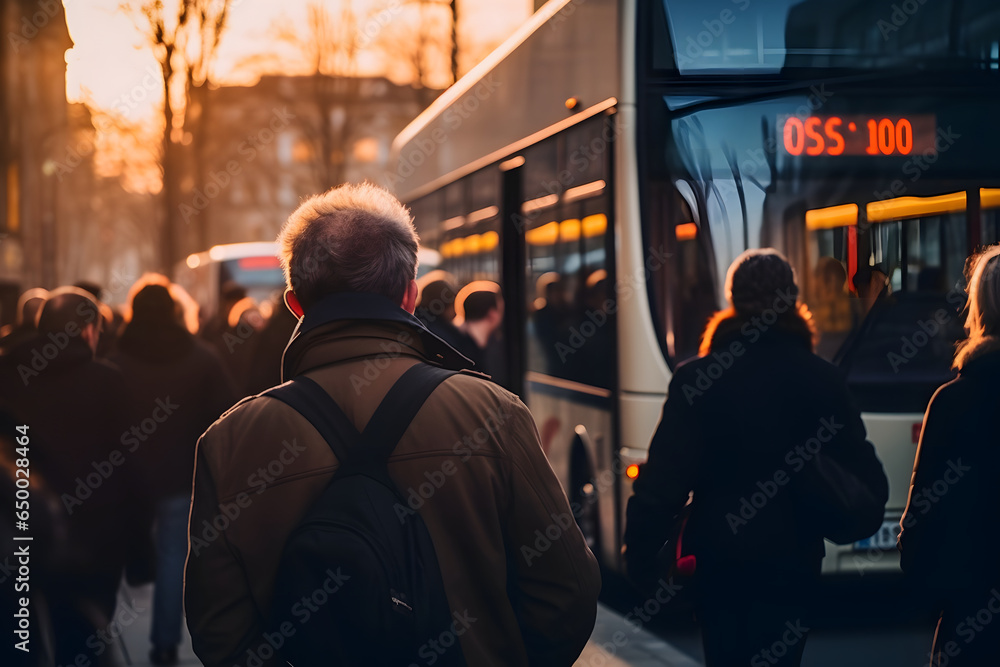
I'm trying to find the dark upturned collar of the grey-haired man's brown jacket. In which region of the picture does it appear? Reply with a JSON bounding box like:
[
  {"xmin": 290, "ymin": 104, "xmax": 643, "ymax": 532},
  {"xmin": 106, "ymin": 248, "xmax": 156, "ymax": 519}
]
[{"xmin": 281, "ymin": 292, "xmax": 472, "ymax": 381}]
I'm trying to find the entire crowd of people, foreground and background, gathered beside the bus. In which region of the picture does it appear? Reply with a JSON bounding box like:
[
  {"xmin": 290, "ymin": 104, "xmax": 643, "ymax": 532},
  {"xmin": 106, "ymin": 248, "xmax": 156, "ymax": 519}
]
[{"xmin": 0, "ymin": 177, "xmax": 1000, "ymax": 666}]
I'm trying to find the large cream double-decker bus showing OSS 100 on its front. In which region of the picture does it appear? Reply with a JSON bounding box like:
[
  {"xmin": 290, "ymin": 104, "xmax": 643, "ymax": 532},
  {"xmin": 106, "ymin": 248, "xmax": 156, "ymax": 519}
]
[{"xmin": 390, "ymin": 0, "xmax": 1000, "ymax": 574}]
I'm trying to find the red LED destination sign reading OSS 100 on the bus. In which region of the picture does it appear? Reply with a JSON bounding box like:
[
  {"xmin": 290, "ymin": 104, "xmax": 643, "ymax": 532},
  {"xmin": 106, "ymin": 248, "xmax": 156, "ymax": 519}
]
[{"xmin": 778, "ymin": 114, "xmax": 937, "ymax": 156}]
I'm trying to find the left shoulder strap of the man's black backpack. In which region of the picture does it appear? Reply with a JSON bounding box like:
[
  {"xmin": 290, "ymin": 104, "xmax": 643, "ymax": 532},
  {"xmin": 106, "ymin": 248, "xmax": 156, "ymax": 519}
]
[{"xmin": 261, "ymin": 375, "xmax": 362, "ymax": 465}]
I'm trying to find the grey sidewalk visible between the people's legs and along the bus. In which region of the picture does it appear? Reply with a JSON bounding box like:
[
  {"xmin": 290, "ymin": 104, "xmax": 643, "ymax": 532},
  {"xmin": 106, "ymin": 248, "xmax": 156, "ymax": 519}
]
[{"xmin": 118, "ymin": 585, "xmax": 701, "ymax": 667}]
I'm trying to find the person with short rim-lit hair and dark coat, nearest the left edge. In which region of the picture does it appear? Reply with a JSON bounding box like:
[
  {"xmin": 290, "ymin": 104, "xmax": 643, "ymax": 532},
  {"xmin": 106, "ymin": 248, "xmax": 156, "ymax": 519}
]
[{"xmin": 0, "ymin": 287, "xmax": 148, "ymax": 665}]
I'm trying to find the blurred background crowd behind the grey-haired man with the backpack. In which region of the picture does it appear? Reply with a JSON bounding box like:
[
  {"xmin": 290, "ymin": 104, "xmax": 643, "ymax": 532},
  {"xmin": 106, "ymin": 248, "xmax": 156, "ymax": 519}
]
[{"xmin": 0, "ymin": 271, "xmax": 504, "ymax": 665}]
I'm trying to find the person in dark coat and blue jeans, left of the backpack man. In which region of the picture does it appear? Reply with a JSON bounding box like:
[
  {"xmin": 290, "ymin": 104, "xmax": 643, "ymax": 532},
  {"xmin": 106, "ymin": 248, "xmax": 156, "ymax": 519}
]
[{"xmin": 110, "ymin": 284, "xmax": 236, "ymax": 665}]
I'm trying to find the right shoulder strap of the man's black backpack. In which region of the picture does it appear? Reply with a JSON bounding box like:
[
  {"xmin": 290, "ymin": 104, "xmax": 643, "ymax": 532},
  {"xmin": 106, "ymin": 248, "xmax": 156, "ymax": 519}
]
[{"xmin": 362, "ymin": 363, "xmax": 458, "ymax": 462}]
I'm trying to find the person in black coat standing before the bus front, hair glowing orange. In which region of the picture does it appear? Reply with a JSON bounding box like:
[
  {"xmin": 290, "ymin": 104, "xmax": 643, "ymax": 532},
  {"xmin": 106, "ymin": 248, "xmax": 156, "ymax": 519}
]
[{"xmin": 624, "ymin": 249, "xmax": 888, "ymax": 667}]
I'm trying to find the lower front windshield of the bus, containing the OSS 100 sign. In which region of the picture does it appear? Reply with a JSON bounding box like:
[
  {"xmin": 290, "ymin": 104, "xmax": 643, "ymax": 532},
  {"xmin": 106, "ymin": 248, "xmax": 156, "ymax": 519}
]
[{"xmin": 640, "ymin": 81, "xmax": 1000, "ymax": 412}]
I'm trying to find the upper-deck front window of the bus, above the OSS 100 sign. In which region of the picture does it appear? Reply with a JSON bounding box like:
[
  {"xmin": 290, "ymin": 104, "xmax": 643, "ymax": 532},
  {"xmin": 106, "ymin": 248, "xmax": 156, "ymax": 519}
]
[{"xmin": 652, "ymin": 0, "xmax": 1000, "ymax": 75}]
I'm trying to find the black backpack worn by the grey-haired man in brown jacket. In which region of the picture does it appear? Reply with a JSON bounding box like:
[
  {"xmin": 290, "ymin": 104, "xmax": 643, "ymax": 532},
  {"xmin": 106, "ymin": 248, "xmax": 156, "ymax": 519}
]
[{"xmin": 264, "ymin": 363, "xmax": 465, "ymax": 667}]
